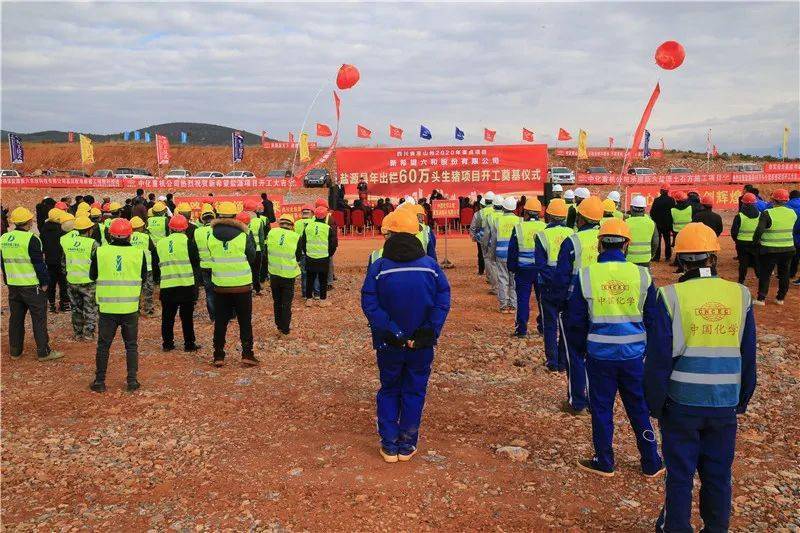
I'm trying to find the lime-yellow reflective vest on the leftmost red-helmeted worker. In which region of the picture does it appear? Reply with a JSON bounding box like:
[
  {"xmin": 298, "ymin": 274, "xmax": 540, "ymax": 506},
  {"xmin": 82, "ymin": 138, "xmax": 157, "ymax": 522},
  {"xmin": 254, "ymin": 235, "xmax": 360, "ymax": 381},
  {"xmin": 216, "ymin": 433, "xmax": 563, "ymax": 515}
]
[{"xmin": 95, "ymin": 244, "xmax": 144, "ymax": 315}]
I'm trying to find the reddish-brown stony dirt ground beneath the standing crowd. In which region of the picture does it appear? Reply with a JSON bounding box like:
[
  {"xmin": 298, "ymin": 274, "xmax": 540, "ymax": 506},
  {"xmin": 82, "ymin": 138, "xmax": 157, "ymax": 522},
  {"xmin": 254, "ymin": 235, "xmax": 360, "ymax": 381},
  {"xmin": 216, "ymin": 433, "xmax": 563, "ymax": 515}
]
[{"xmin": 1, "ymin": 214, "xmax": 800, "ymax": 531}]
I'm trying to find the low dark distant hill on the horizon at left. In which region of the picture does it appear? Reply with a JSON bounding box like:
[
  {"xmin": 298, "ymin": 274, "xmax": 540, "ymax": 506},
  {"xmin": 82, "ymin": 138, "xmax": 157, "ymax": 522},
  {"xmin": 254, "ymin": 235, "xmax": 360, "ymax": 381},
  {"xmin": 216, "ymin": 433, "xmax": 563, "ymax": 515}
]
[{"xmin": 2, "ymin": 122, "xmax": 272, "ymax": 145}]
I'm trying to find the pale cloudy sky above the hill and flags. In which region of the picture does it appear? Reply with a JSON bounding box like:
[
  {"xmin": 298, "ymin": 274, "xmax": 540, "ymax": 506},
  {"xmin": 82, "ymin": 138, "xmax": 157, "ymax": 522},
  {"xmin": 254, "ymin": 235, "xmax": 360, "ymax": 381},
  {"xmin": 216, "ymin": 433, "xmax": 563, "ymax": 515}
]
[{"xmin": 0, "ymin": 1, "xmax": 800, "ymax": 157}]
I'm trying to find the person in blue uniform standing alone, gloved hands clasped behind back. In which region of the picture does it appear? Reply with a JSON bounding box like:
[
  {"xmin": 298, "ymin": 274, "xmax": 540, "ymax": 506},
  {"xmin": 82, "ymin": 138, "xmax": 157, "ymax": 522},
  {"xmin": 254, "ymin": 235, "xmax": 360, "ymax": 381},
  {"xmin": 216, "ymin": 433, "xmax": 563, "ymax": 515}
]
[{"xmin": 361, "ymin": 208, "xmax": 450, "ymax": 463}]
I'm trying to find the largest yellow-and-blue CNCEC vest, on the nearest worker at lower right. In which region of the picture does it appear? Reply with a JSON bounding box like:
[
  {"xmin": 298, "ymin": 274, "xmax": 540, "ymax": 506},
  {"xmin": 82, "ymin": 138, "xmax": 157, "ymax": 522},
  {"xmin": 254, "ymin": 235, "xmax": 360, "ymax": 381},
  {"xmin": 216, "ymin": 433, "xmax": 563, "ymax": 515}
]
[{"xmin": 659, "ymin": 278, "xmax": 751, "ymax": 407}]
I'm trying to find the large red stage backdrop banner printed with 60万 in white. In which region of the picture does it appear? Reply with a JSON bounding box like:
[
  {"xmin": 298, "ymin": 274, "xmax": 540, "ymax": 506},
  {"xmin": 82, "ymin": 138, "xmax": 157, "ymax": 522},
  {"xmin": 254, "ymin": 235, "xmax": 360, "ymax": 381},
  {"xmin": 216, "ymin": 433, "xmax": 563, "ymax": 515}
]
[{"xmin": 336, "ymin": 144, "xmax": 547, "ymax": 197}]
